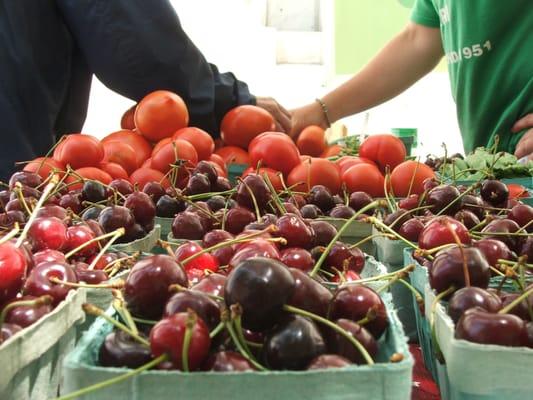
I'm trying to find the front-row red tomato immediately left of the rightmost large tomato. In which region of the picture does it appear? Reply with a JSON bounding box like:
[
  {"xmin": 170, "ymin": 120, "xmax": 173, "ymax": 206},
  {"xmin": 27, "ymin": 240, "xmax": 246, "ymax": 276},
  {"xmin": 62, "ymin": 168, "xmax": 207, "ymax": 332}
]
[{"xmin": 342, "ymin": 164, "xmax": 385, "ymax": 197}]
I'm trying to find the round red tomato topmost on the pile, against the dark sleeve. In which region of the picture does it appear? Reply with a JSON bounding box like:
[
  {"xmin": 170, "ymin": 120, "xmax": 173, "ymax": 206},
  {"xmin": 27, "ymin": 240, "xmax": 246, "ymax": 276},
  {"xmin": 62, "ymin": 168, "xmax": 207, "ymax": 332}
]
[{"xmin": 135, "ymin": 90, "xmax": 189, "ymax": 142}]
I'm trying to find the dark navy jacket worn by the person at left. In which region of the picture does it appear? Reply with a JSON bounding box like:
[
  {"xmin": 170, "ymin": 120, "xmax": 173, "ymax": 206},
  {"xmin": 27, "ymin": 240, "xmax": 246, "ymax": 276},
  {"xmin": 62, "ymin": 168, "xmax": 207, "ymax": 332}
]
[{"xmin": 0, "ymin": 0, "xmax": 255, "ymax": 179}]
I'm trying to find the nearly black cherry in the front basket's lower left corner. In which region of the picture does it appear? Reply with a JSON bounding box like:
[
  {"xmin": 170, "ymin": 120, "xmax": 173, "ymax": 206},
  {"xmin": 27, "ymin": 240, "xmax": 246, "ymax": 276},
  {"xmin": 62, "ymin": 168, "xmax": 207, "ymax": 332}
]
[{"xmin": 98, "ymin": 330, "xmax": 152, "ymax": 369}]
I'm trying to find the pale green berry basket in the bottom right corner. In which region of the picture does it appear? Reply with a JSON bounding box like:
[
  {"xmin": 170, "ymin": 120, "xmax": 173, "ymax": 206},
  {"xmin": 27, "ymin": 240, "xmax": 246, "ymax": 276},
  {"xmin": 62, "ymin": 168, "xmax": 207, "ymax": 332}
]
[{"xmin": 426, "ymin": 285, "xmax": 533, "ymax": 400}]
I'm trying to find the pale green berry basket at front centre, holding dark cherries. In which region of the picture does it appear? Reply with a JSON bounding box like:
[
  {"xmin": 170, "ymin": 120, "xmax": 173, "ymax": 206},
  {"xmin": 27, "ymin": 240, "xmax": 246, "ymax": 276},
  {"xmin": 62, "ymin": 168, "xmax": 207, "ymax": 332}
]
[{"xmin": 61, "ymin": 293, "xmax": 413, "ymax": 400}]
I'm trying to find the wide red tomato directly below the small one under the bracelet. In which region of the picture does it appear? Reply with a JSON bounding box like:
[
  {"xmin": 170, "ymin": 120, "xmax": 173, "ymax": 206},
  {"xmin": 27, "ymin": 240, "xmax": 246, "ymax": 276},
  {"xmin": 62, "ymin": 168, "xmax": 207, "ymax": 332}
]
[{"xmin": 287, "ymin": 158, "xmax": 341, "ymax": 193}]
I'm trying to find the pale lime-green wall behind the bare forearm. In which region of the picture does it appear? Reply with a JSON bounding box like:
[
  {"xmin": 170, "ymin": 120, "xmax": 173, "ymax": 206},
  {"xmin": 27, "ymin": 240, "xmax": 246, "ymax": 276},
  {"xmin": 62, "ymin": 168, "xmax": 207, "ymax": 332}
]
[{"xmin": 335, "ymin": 0, "xmax": 445, "ymax": 75}]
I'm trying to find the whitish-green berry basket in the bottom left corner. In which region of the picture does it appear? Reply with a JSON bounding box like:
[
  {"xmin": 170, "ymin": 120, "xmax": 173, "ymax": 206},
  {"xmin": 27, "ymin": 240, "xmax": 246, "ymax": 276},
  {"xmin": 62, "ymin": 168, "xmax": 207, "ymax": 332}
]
[{"xmin": 0, "ymin": 289, "xmax": 86, "ymax": 400}]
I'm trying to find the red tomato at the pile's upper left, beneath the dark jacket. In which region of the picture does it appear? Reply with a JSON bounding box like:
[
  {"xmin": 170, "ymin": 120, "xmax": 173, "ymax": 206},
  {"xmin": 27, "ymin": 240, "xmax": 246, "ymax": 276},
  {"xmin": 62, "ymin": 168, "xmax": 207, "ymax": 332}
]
[{"xmin": 54, "ymin": 133, "xmax": 104, "ymax": 169}]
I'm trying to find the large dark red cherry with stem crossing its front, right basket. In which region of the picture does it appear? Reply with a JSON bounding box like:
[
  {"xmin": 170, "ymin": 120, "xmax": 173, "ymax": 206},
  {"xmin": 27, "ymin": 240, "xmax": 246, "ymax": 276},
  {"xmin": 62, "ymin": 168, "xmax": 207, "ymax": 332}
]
[{"xmin": 429, "ymin": 246, "xmax": 490, "ymax": 298}]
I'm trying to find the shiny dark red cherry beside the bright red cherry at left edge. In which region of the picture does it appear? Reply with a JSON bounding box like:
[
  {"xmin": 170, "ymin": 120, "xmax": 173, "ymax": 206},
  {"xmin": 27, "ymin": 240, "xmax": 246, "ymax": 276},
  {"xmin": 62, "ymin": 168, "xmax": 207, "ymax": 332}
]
[{"xmin": 23, "ymin": 261, "xmax": 78, "ymax": 305}]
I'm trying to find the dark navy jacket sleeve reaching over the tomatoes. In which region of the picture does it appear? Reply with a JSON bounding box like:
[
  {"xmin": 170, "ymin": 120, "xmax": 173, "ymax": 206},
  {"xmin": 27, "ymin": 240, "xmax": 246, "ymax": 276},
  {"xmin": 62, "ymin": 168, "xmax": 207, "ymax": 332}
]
[{"xmin": 57, "ymin": 0, "xmax": 255, "ymax": 136}]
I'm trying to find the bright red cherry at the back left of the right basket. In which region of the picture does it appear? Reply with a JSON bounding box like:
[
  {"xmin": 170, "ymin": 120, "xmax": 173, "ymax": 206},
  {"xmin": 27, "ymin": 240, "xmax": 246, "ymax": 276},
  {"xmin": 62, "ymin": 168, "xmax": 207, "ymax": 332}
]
[{"xmin": 418, "ymin": 216, "xmax": 471, "ymax": 249}]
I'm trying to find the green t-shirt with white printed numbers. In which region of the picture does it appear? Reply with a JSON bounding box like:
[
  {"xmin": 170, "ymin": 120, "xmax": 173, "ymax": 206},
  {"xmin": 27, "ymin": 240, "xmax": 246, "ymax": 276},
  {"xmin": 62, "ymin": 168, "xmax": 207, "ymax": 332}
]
[{"xmin": 411, "ymin": 0, "xmax": 533, "ymax": 153}]
